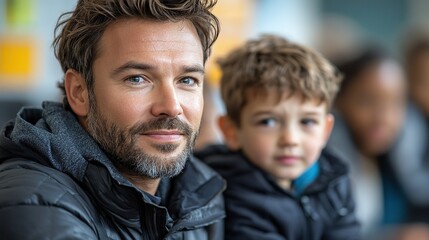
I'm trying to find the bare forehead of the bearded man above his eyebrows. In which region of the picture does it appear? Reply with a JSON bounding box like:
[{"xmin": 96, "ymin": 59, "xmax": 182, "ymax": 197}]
[{"xmin": 98, "ymin": 19, "xmax": 203, "ymax": 61}]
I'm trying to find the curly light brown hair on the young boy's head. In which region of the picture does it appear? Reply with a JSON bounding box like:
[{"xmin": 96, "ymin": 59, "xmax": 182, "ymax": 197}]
[{"xmin": 218, "ymin": 35, "xmax": 342, "ymax": 126}]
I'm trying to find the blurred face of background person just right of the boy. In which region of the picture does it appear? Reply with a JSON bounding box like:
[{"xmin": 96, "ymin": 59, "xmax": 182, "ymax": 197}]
[{"xmin": 337, "ymin": 61, "xmax": 406, "ymax": 157}]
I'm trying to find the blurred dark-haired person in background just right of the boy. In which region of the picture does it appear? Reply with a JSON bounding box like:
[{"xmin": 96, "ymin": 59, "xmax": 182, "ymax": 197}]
[{"xmin": 327, "ymin": 48, "xmax": 428, "ymax": 239}]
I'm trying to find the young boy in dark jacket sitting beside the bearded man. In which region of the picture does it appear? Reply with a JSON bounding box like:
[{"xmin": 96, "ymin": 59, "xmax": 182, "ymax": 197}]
[{"xmin": 197, "ymin": 35, "xmax": 360, "ymax": 240}]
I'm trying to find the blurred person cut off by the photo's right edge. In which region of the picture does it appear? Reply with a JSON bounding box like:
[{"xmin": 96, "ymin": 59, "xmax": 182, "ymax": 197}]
[{"xmin": 392, "ymin": 30, "xmax": 429, "ymax": 216}]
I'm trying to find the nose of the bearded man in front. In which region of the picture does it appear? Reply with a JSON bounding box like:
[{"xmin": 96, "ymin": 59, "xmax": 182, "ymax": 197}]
[{"xmin": 151, "ymin": 84, "xmax": 183, "ymax": 117}]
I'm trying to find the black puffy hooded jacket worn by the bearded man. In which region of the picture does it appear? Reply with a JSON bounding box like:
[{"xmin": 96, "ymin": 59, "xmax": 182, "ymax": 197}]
[{"xmin": 0, "ymin": 103, "xmax": 225, "ymax": 240}]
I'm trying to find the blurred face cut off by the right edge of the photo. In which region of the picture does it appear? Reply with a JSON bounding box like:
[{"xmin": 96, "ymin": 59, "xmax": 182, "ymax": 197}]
[{"xmin": 408, "ymin": 49, "xmax": 429, "ymax": 117}]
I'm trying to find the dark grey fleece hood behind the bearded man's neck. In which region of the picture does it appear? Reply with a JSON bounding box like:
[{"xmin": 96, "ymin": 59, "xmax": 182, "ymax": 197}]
[{"xmin": 0, "ymin": 102, "xmax": 129, "ymax": 185}]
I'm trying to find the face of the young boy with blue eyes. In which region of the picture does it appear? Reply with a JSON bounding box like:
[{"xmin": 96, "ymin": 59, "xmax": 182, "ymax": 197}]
[{"xmin": 221, "ymin": 90, "xmax": 334, "ymax": 188}]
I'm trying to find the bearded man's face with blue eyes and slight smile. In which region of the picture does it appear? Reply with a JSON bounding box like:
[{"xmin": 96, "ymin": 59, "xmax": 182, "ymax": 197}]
[{"xmin": 87, "ymin": 19, "xmax": 204, "ymax": 178}]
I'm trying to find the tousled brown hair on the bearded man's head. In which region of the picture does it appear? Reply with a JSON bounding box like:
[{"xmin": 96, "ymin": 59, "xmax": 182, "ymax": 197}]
[{"xmin": 53, "ymin": 0, "xmax": 220, "ymax": 109}]
